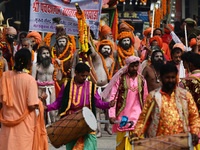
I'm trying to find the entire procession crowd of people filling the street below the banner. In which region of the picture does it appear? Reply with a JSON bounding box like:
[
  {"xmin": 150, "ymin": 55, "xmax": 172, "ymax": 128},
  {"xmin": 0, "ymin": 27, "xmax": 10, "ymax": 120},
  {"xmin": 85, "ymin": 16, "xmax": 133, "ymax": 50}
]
[{"xmin": 0, "ymin": 15, "xmax": 200, "ymax": 150}]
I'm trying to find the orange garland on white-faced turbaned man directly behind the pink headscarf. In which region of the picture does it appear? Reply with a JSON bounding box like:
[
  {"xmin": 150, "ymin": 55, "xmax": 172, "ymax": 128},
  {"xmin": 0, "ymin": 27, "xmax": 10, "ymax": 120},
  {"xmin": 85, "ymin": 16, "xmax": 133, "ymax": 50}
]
[{"xmin": 118, "ymin": 46, "xmax": 135, "ymax": 67}]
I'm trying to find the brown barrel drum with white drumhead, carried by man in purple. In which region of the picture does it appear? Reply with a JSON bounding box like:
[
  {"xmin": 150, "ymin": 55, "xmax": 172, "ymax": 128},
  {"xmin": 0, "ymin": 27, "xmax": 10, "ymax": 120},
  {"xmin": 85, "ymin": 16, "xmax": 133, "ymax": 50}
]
[{"xmin": 47, "ymin": 107, "xmax": 97, "ymax": 148}]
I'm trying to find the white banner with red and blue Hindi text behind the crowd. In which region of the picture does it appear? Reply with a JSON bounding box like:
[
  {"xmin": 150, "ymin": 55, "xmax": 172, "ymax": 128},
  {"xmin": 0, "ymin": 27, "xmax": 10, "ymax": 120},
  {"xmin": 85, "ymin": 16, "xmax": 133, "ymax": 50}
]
[{"xmin": 29, "ymin": 0, "xmax": 102, "ymax": 37}]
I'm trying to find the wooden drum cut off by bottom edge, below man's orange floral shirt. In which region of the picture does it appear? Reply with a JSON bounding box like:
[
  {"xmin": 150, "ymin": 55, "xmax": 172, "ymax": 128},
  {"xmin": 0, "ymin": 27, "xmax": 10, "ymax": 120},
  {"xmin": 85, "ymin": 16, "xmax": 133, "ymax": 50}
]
[{"xmin": 131, "ymin": 133, "xmax": 194, "ymax": 150}]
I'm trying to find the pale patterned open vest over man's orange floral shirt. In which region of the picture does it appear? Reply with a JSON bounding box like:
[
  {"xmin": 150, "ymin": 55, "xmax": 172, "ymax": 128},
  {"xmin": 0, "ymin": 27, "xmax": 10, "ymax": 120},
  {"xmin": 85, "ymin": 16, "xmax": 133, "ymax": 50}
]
[{"xmin": 145, "ymin": 87, "xmax": 189, "ymax": 138}]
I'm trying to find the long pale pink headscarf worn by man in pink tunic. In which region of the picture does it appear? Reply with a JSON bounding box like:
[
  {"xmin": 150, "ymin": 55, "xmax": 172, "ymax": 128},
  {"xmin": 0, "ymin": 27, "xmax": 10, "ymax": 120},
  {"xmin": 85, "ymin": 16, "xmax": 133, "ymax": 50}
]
[{"xmin": 101, "ymin": 55, "xmax": 141, "ymax": 99}]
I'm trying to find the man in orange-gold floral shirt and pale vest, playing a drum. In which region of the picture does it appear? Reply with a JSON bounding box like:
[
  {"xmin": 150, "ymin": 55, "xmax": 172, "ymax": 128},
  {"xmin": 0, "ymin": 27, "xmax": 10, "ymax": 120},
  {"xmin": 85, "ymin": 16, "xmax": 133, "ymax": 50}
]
[{"xmin": 130, "ymin": 62, "xmax": 200, "ymax": 148}]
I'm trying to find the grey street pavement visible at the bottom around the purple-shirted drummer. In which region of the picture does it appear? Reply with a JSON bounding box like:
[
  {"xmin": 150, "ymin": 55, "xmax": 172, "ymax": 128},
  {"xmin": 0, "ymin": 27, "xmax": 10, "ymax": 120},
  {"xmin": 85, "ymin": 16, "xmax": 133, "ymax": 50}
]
[{"xmin": 49, "ymin": 125, "xmax": 116, "ymax": 150}]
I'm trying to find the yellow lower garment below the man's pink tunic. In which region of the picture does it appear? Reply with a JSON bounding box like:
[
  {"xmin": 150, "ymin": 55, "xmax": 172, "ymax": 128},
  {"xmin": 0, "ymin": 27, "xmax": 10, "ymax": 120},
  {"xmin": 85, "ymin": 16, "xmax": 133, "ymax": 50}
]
[{"xmin": 116, "ymin": 131, "xmax": 133, "ymax": 150}]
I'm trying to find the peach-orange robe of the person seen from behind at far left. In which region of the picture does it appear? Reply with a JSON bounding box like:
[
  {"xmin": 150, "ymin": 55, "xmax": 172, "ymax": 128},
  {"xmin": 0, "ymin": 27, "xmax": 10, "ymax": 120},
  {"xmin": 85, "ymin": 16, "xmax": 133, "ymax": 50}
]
[{"xmin": 0, "ymin": 71, "xmax": 48, "ymax": 150}]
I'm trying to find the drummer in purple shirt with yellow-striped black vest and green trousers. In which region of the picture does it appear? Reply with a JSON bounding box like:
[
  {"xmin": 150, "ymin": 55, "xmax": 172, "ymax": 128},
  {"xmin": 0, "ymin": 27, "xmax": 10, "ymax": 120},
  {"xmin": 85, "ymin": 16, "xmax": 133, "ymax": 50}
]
[{"xmin": 45, "ymin": 63, "xmax": 115, "ymax": 150}]
